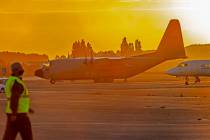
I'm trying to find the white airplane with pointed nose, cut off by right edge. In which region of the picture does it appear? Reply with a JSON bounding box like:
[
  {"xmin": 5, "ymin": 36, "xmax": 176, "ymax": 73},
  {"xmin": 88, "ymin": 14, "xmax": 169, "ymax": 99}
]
[{"xmin": 166, "ymin": 60, "xmax": 210, "ymax": 85}]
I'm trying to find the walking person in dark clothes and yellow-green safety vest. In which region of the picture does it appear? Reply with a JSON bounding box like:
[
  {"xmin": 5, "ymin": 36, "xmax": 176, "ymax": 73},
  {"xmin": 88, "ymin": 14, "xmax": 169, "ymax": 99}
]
[{"xmin": 3, "ymin": 63, "xmax": 34, "ymax": 140}]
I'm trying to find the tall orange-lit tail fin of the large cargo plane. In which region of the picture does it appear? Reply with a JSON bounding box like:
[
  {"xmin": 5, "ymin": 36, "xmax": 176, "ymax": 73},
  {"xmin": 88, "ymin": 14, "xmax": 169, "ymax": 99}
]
[{"xmin": 156, "ymin": 19, "xmax": 186, "ymax": 59}]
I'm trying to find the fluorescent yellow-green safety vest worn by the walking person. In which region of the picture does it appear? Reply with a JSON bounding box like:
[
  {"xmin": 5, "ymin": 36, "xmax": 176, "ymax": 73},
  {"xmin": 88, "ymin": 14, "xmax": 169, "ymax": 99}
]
[{"xmin": 5, "ymin": 76, "xmax": 30, "ymax": 114}]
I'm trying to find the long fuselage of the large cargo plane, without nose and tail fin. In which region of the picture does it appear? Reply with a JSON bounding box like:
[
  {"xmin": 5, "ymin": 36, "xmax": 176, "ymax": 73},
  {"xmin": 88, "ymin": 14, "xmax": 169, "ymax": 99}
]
[{"xmin": 37, "ymin": 54, "xmax": 164, "ymax": 80}]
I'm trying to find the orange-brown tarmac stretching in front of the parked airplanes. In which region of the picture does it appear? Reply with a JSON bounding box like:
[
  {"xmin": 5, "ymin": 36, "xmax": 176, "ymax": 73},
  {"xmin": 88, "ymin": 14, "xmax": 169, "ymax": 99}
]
[{"xmin": 0, "ymin": 73, "xmax": 210, "ymax": 140}]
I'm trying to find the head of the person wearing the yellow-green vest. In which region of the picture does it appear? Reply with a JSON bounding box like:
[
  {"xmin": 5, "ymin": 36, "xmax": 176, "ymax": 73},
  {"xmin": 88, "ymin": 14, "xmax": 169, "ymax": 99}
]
[{"xmin": 11, "ymin": 62, "xmax": 24, "ymax": 76}]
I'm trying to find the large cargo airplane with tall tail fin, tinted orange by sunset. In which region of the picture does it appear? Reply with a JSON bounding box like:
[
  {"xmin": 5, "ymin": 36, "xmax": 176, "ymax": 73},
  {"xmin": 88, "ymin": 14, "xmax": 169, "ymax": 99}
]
[{"xmin": 35, "ymin": 19, "xmax": 186, "ymax": 84}]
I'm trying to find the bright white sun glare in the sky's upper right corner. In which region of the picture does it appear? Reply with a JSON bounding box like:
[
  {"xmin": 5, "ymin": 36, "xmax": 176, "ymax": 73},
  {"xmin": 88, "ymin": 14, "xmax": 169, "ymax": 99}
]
[{"xmin": 175, "ymin": 0, "xmax": 210, "ymax": 43}]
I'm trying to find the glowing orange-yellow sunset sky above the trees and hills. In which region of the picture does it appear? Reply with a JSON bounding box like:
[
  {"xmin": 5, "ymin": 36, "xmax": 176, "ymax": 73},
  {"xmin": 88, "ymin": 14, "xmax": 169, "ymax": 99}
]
[{"xmin": 0, "ymin": 0, "xmax": 210, "ymax": 58}]
